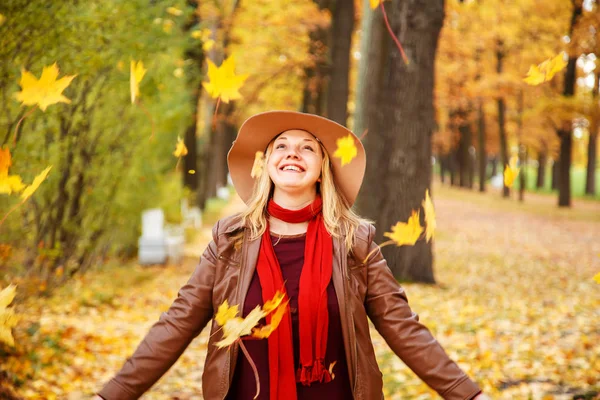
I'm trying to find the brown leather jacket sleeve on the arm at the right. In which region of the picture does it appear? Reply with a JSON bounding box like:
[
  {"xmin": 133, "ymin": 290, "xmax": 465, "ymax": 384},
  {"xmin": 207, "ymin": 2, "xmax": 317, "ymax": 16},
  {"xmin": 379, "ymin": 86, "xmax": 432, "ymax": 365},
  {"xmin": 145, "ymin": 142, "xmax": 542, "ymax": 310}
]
[{"xmin": 365, "ymin": 225, "xmax": 480, "ymax": 400}]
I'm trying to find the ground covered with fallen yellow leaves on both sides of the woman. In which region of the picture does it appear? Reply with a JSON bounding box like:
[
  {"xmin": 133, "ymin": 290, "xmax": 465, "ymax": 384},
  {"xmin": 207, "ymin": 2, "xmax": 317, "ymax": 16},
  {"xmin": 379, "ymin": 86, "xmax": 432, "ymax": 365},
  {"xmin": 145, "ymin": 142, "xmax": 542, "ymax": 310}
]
[{"xmin": 2, "ymin": 187, "xmax": 600, "ymax": 399}]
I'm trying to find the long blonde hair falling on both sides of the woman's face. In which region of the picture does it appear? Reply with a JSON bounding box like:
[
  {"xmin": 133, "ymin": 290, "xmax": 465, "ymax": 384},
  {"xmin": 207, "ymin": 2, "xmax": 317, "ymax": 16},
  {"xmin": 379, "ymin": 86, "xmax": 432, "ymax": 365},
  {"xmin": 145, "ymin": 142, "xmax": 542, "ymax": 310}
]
[{"xmin": 240, "ymin": 137, "xmax": 372, "ymax": 252}]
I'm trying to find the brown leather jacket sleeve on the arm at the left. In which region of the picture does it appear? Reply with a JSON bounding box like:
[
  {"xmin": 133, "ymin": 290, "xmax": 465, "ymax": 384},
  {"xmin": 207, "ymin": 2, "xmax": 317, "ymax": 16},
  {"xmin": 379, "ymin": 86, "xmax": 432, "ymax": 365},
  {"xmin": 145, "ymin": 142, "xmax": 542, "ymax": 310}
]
[{"xmin": 98, "ymin": 223, "xmax": 218, "ymax": 400}]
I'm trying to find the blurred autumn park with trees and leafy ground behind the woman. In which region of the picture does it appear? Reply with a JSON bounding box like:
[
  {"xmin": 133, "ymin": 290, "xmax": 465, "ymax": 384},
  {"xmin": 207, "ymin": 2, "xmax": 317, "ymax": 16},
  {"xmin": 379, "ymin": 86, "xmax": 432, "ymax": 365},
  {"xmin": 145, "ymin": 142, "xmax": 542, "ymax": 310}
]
[{"xmin": 0, "ymin": 0, "xmax": 600, "ymax": 399}]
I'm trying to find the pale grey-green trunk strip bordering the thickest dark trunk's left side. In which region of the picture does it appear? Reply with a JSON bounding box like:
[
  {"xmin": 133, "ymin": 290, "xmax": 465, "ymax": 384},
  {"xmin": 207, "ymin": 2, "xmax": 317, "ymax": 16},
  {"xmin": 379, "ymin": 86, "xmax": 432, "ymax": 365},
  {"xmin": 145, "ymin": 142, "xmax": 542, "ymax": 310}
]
[{"xmin": 354, "ymin": 0, "xmax": 386, "ymax": 136}]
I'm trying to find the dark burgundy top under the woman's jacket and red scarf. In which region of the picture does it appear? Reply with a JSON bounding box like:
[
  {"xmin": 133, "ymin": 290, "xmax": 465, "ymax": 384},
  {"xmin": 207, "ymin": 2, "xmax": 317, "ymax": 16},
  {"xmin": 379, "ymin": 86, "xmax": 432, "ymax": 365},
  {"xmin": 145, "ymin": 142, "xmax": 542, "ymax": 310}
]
[{"xmin": 227, "ymin": 234, "xmax": 352, "ymax": 400}]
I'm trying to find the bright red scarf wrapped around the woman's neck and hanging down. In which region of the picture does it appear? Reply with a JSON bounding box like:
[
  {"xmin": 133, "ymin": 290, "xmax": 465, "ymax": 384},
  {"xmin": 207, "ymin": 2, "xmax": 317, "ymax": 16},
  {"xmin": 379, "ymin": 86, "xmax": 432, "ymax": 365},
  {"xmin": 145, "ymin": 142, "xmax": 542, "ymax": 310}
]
[{"xmin": 256, "ymin": 197, "xmax": 333, "ymax": 400}]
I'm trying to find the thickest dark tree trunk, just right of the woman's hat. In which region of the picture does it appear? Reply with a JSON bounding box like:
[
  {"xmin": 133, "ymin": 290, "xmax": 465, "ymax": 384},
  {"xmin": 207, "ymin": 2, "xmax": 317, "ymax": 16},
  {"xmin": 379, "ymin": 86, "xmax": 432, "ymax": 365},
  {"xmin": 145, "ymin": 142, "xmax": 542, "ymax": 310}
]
[{"xmin": 358, "ymin": 0, "xmax": 444, "ymax": 283}]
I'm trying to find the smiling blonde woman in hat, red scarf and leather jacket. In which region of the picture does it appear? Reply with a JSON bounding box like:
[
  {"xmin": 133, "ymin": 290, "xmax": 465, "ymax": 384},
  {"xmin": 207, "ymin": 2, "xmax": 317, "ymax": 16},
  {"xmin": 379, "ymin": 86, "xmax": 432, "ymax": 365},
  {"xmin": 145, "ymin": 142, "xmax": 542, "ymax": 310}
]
[{"xmin": 97, "ymin": 111, "xmax": 487, "ymax": 400}]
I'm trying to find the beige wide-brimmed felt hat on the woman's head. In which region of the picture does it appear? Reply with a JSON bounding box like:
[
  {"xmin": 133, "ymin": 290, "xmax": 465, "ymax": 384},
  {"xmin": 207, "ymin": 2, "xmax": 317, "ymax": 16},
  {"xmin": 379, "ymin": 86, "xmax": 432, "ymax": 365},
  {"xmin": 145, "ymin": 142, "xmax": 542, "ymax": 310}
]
[{"xmin": 227, "ymin": 111, "xmax": 367, "ymax": 206}]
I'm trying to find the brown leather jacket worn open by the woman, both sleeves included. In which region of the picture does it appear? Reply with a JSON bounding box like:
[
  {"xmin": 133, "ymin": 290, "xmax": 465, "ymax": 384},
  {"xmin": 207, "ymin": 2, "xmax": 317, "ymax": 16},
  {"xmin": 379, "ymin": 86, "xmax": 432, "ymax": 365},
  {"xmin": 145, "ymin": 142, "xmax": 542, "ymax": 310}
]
[{"xmin": 99, "ymin": 215, "xmax": 479, "ymax": 400}]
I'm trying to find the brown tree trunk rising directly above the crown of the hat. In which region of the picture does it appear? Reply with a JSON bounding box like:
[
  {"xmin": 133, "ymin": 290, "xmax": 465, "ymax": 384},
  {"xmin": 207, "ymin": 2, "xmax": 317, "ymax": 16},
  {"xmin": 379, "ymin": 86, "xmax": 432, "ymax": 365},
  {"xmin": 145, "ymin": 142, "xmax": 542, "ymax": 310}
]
[{"xmin": 327, "ymin": 0, "xmax": 354, "ymax": 126}]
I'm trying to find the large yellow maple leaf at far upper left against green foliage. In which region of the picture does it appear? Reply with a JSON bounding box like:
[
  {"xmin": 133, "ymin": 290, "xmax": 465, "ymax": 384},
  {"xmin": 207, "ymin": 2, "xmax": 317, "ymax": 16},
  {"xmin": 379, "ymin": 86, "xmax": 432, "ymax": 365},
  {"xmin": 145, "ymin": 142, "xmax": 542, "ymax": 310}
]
[{"xmin": 14, "ymin": 63, "xmax": 76, "ymax": 111}]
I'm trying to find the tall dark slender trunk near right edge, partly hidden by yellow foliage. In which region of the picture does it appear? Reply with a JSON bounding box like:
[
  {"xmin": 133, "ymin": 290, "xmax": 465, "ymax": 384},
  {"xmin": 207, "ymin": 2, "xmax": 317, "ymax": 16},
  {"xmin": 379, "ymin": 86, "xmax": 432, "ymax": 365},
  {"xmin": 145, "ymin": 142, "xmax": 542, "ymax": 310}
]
[{"xmin": 556, "ymin": 2, "xmax": 583, "ymax": 207}]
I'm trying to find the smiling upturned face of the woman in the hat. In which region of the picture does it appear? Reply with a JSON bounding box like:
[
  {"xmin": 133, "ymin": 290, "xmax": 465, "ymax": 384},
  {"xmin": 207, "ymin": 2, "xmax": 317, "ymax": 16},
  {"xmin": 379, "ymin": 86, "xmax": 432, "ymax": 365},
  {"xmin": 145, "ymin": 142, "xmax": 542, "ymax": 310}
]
[{"xmin": 267, "ymin": 129, "xmax": 323, "ymax": 199}]
